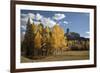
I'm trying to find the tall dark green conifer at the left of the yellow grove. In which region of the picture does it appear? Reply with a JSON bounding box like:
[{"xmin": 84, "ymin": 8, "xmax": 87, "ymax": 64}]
[{"xmin": 23, "ymin": 18, "xmax": 35, "ymax": 56}]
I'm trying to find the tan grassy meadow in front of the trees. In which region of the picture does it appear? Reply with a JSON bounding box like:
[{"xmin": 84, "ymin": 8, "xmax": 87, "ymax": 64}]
[{"xmin": 21, "ymin": 51, "xmax": 89, "ymax": 63}]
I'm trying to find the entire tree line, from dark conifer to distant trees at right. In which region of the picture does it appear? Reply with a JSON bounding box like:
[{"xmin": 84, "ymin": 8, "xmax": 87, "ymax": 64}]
[{"xmin": 21, "ymin": 19, "xmax": 89, "ymax": 58}]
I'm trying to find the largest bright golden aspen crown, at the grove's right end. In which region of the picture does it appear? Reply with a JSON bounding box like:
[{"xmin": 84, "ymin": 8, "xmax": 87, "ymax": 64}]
[{"xmin": 51, "ymin": 25, "xmax": 66, "ymax": 49}]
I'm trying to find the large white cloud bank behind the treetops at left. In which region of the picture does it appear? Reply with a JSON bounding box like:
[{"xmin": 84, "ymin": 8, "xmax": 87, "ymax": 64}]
[{"xmin": 21, "ymin": 13, "xmax": 56, "ymax": 28}]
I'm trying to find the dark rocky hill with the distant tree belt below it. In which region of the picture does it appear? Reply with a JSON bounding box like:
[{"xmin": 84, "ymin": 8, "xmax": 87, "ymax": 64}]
[{"xmin": 65, "ymin": 30, "xmax": 89, "ymax": 50}]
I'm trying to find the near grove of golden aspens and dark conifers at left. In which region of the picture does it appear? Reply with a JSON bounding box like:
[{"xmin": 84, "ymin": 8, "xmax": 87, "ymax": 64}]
[{"xmin": 21, "ymin": 20, "xmax": 67, "ymax": 57}]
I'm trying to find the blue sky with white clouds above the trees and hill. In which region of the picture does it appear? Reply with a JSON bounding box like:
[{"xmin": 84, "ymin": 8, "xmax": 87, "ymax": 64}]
[{"xmin": 21, "ymin": 10, "xmax": 90, "ymax": 37}]
